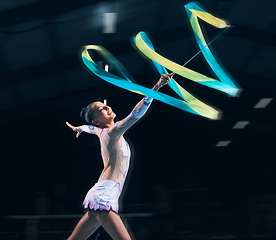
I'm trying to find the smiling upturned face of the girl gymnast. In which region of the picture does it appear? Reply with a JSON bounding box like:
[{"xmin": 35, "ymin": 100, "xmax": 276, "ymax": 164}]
[{"xmin": 91, "ymin": 102, "xmax": 116, "ymax": 126}]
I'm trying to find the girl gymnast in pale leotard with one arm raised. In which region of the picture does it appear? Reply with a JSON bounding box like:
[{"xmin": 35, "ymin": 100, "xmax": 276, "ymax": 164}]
[{"xmin": 66, "ymin": 73, "xmax": 173, "ymax": 240}]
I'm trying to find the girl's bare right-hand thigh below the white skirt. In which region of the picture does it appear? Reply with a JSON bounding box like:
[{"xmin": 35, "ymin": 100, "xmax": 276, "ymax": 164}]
[{"xmin": 95, "ymin": 211, "xmax": 131, "ymax": 240}]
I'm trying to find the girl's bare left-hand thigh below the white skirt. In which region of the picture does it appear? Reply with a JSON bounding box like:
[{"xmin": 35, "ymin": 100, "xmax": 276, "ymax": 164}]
[{"xmin": 68, "ymin": 212, "xmax": 100, "ymax": 240}]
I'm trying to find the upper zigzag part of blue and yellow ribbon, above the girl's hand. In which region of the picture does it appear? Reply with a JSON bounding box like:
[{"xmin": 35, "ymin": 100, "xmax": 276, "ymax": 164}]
[{"xmin": 134, "ymin": 2, "xmax": 239, "ymax": 96}]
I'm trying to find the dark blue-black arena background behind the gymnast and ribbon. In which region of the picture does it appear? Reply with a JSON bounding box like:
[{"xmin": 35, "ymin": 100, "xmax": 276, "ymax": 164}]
[{"xmin": 0, "ymin": 0, "xmax": 276, "ymax": 240}]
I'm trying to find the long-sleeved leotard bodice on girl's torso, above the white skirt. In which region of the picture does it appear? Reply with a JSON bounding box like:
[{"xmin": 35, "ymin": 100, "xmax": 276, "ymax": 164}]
[{"xmin": 82, "ymin": 97, "xmax": 152, "ymax": 192}]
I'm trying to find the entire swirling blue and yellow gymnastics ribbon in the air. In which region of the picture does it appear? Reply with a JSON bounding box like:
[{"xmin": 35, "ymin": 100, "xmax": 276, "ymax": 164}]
[{"xmin": 82, "ymin": 3, "xmax": 239, "ymax": 119}]
